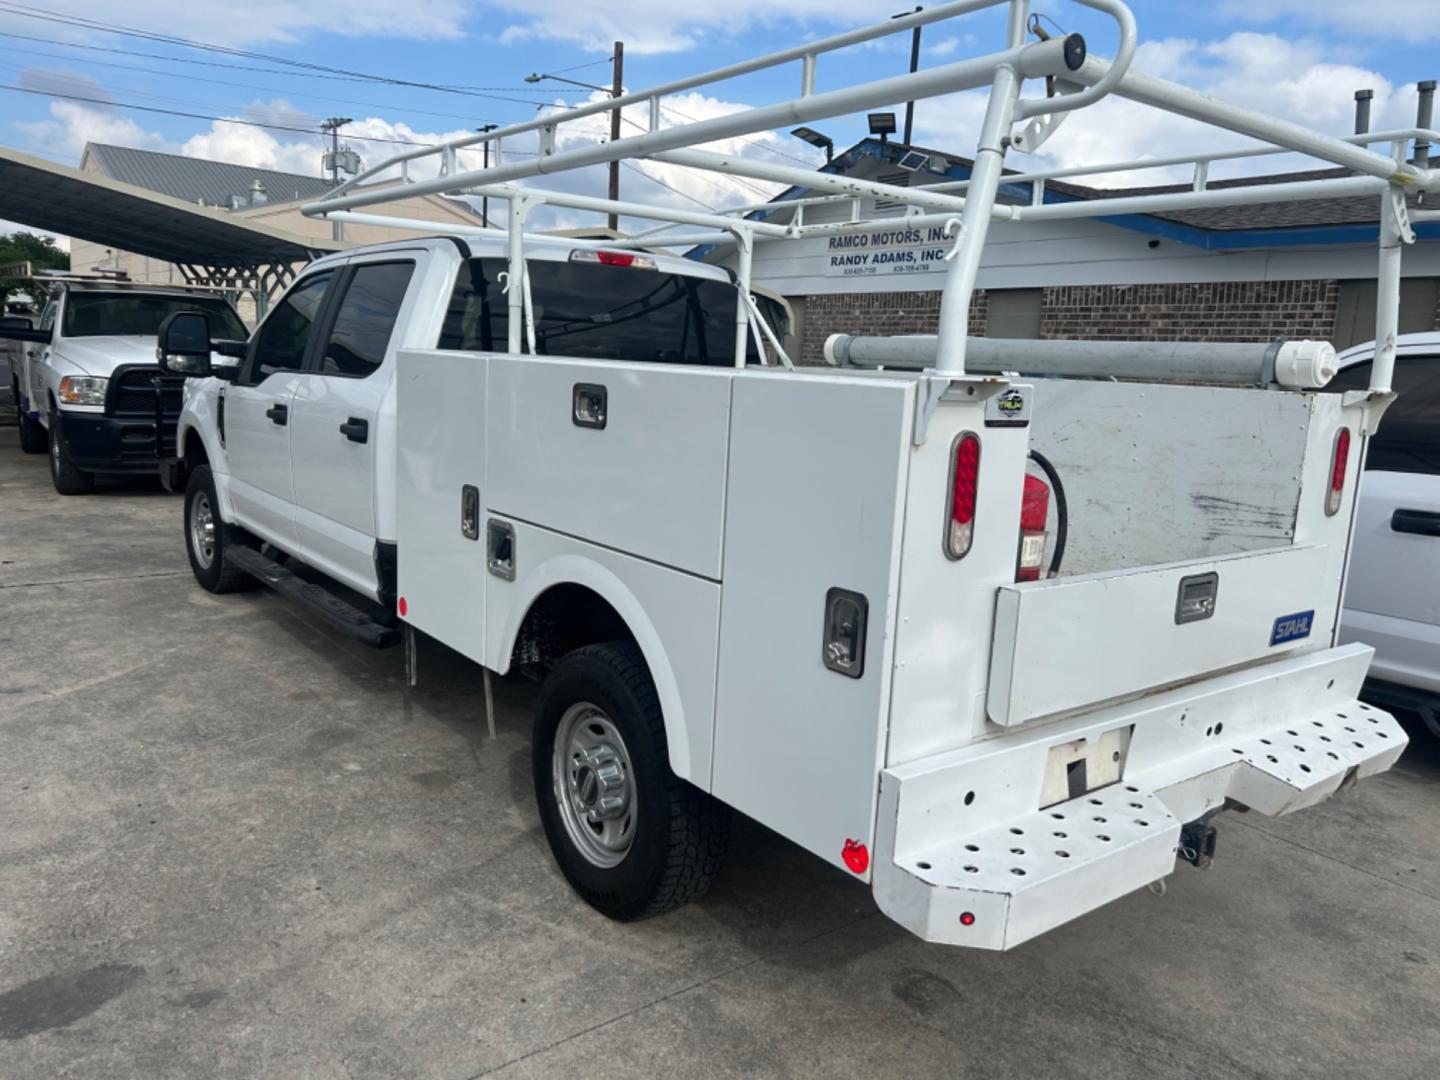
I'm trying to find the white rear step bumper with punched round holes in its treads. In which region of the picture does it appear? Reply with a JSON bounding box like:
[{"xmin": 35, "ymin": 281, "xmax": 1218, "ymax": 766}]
[{"xmin": 874, "ymin": 645, "xmax": 1407, "ymax": 949}]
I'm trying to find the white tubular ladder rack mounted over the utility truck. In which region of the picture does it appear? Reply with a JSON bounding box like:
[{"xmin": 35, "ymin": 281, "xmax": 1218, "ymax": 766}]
[{"xmin": 302, "ymin": 0, "xmax": 1440, "ymax": 408}]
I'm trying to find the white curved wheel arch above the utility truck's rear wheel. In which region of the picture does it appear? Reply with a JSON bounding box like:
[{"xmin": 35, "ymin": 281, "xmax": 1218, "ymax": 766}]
[{"xmin": 487, "ymin": 554, "xmax": 699, "ymax": 789}]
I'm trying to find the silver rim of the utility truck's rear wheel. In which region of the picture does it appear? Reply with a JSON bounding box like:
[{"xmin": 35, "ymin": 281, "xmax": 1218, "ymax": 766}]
[{"xmin": 552, "ymin": 701, "xmax": 635, "ymax": 870}]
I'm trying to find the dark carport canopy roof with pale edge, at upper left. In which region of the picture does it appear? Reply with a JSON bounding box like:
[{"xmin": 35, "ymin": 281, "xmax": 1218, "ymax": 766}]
[{"xmin": 0, "ymin": 148, "xmax": 348, "ymax": 268}]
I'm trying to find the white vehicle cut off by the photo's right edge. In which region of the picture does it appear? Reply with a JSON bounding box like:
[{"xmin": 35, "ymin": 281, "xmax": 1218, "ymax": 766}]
[{"xmin": 1331, "ymin": 331, "xmax": 1440, "ymax": 736}]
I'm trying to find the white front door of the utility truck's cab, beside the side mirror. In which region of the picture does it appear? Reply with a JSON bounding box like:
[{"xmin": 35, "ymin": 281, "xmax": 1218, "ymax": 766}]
[{"xmin": 223, "ymin": 271, "xmax": 337, "ymax": 553}]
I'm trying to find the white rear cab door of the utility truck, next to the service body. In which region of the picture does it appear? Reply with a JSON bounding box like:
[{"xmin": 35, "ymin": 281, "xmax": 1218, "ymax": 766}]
[{"xmin": 289, "ymin": 256, "xmax": 415, "ymax": 595}]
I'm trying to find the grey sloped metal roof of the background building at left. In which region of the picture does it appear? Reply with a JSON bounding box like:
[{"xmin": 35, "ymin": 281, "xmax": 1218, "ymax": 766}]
[{"xmin": 85, "ymin": 143, "xmax": 333, "ymax": 206}]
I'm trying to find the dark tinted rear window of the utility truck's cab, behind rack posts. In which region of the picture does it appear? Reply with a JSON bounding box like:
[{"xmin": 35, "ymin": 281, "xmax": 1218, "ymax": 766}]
[{"xmin": 439, "ymin": 259, "xmax": 756, "ymax": 367}]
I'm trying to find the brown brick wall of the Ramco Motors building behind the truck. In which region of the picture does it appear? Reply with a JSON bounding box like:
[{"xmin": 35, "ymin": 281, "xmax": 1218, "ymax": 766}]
[{"xmin": 801, "ymin": 279, "xmax": 1339, "ymax": 364}]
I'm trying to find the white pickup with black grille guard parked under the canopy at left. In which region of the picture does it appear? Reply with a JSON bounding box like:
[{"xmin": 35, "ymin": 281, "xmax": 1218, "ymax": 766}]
[{"xmin": 0, "ymin": 276, "xmax": 248, "ymax": 495}]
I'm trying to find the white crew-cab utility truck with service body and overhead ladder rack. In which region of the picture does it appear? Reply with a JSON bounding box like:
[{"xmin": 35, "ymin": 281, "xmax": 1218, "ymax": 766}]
[{"xmin": 160, "ymin": 0, "xmax": 1440, "ymax": 949}]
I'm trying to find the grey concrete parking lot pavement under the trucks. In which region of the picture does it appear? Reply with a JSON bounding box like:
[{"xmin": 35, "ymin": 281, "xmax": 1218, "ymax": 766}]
[{"xmin": 0, "ymin": 426, "xmax": 1440, "ymax": 1080}]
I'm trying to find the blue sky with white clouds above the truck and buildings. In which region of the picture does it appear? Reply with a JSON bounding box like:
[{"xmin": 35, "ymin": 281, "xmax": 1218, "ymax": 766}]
[{"xmin": 0, "ymin": 0, "xmax": 1440, "ymax": 244}]
